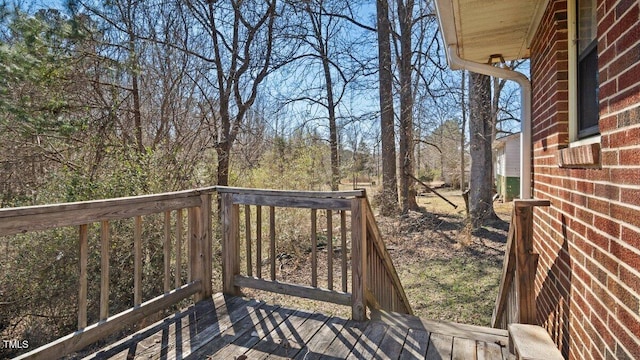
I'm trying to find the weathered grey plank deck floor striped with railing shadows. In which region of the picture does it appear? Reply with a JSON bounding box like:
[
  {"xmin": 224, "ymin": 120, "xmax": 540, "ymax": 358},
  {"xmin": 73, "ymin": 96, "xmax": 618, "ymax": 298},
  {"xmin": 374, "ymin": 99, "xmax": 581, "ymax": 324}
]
[{"xmin": 86, "ymin": 294, "xmax": 509, "ymax": 359}]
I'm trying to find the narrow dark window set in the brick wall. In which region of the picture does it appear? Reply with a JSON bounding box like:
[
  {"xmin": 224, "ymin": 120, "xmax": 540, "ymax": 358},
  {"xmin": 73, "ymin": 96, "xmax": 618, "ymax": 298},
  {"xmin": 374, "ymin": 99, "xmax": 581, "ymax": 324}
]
[{"xmin": 575, "ymin": 0, "xmax": 600, "ymax": 140}]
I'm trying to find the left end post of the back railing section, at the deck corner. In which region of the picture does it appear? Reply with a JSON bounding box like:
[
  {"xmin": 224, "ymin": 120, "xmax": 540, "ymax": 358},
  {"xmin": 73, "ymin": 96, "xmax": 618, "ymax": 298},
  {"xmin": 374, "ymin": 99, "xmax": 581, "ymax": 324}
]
[{"xmin": 220, "ymin": 193, "xmax": 240, "ymax": 296}]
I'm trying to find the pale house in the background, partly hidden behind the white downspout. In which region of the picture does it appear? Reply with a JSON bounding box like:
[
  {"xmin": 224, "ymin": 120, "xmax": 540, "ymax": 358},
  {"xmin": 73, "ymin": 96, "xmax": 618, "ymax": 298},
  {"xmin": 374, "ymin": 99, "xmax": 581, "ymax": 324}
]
[{"xmin": 494, "ymin": 133, "xmax": 520, "ymax": 201}]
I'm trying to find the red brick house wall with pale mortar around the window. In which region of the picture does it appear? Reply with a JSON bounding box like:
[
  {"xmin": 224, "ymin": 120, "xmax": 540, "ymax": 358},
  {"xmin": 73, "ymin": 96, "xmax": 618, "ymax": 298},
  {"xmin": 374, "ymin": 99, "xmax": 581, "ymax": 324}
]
[{"xmin": 531, "ymin": 0, "xmax": 640, "ymax": 359}]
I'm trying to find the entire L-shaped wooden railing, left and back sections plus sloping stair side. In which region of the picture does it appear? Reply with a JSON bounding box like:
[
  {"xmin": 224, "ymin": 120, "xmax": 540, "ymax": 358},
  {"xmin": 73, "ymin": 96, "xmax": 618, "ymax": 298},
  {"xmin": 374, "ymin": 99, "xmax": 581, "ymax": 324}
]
[{"xmin": 5, "ymin": 187, "xmax": 411, "ymax": 359}]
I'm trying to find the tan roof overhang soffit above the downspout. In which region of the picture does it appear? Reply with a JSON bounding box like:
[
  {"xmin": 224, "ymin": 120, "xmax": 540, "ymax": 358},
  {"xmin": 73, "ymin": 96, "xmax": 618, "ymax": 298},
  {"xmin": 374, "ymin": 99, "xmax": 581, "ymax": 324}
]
[{"xmin": 435, "ymin": 0, "xmax": 548, "ymax": 68}]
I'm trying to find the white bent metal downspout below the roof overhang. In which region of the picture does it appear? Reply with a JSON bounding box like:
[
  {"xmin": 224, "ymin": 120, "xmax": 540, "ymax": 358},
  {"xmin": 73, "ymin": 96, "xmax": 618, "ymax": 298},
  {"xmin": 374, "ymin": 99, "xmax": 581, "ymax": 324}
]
[{"xmin": 447, "ymin": 45, "xmax": 531, "ymax": 199}]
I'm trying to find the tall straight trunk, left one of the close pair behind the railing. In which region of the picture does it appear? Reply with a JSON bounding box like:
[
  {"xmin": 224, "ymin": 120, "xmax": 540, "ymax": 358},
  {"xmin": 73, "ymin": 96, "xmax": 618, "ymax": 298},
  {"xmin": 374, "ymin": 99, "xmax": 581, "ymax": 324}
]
[{"xmin": 376, "ymin": 0, "xmax": 398, "ymax": 215}]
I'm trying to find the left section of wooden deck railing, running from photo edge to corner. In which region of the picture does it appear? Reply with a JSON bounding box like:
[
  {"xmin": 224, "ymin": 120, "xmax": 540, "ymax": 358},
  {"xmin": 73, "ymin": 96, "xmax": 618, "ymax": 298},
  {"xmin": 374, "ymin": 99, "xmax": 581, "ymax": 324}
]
[{"xmin": 0, "ymin": 188, "xmax": 215, "ymax": 359}]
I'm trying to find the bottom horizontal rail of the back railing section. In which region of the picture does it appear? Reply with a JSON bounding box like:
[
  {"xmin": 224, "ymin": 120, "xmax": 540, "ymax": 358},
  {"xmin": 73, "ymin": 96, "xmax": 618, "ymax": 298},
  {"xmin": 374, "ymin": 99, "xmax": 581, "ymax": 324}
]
[{"xmin": 234, "ymin": 275, "xmax": 351, "ymax": 305}]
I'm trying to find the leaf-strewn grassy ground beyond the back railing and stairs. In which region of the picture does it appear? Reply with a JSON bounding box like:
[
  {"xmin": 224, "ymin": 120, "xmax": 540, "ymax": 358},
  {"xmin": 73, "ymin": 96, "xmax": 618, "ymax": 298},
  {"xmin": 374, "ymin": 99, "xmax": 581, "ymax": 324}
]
[{"xmin": 245, "ymin": 188, "xmax": 511, "ymax": 326}]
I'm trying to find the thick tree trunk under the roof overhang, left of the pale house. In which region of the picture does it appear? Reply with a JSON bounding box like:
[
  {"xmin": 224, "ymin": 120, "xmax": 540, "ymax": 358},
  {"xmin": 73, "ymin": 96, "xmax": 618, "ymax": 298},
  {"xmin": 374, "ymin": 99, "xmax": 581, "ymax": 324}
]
[{"xmin": 469, "ymin": 73, "xmax": 497, "ymax": 229}]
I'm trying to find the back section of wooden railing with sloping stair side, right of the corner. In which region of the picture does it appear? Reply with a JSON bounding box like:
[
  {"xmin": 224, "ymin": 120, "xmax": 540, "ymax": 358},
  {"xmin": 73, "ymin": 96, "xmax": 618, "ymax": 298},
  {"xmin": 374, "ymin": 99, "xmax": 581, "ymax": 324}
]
[{"xmin": 217, "ymin": 187, "xmax": 411, "ymax": 320}]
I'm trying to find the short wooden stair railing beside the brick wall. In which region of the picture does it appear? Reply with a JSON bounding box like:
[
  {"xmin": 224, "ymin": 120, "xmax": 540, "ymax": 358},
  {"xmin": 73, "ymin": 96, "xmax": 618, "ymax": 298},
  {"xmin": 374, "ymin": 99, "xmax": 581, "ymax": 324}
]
[{"xmin": 491, "ymin": 200, "xmax": 550, "ymax": 329}]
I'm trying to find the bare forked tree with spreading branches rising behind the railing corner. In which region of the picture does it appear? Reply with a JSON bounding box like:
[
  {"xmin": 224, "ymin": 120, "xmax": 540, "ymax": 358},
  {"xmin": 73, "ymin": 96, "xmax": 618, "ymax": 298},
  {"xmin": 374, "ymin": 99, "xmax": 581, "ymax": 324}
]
[{"xmin": 180, "ymin": 0, "xmax": 278, "ymax": 185}]
